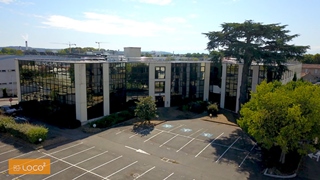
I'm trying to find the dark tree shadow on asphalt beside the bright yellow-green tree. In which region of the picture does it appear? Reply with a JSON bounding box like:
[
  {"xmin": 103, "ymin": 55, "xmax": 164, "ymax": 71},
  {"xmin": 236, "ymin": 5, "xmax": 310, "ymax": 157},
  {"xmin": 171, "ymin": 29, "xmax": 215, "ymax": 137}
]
[{"xmin": 207, "ymin": 129, "xmax": 271, "ymax": 180}]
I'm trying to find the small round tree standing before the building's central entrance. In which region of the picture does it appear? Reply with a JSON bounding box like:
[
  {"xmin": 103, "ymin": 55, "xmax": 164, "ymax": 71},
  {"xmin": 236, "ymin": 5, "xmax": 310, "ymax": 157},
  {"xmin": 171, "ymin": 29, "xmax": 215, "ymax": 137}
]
[{"xmin": 134, "ymin": 96, "xmax": 157, "ymax": 123}]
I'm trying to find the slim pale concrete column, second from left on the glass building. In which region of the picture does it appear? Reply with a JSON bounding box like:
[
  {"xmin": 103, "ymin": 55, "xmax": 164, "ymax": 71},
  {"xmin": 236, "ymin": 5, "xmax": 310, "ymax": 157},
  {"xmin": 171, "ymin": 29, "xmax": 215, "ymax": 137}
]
[{"xmin": 102, "ymin": 63, "xmax": 110, "ymax": 116}]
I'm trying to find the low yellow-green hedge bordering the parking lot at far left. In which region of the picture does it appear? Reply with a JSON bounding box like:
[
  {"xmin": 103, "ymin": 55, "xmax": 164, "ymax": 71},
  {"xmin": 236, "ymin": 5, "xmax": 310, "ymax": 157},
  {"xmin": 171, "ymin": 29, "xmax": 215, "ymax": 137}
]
[{"xmin": 0, "ymin": 117, "xmax": 48, "ymax": 144}]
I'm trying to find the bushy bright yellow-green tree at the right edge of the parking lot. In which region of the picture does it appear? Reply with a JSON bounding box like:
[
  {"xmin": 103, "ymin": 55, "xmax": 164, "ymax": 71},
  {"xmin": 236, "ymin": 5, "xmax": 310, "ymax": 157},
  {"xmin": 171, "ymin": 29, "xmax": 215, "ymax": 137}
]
[{"xmin": 238, "ymin": 81, "xmax": 320, "ymax": 163}]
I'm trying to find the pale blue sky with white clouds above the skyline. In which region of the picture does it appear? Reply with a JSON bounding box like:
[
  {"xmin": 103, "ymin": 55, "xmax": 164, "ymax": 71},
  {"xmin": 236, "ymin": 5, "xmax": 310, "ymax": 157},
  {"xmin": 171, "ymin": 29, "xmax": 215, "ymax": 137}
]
[{"xmin": 0, "ymin": 0, "xmax": 320, "ymax": 54}]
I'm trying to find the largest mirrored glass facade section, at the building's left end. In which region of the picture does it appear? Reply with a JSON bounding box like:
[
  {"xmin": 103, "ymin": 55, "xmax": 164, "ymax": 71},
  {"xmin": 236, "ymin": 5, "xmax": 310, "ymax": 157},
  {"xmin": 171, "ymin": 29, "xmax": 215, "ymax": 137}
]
[{"xmin": 18, "ymin": 60, "xmax": 75, "ymax": 121}]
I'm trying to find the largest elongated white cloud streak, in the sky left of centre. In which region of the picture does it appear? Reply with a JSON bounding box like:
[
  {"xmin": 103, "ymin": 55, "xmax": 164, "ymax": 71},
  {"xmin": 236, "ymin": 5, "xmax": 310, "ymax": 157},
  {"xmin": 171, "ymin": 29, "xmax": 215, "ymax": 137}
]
[{"xmin": 42, "ymin": 12, "xmax": 175, "ymax": 36}]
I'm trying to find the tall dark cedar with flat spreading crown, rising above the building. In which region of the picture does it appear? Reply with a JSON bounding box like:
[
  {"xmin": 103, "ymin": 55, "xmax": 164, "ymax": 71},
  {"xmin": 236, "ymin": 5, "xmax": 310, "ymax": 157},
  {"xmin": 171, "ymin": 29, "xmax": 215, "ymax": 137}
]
[{"xmin": 203, "ymin": 20, "xmax": 309, "ymax": 112}]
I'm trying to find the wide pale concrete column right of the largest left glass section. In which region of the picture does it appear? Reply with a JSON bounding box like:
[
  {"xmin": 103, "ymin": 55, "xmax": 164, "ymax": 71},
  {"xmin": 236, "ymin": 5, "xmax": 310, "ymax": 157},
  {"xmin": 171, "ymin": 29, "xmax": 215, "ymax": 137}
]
[{"xmin": 74, "ymin": 64, "xmax": 88, "ymax": 124}]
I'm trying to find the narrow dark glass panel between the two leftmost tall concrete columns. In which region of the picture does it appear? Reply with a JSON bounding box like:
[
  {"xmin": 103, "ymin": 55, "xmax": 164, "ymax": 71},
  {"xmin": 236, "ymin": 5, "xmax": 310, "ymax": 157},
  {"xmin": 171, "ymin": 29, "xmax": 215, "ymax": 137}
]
[{"xmin": 86, "ymin": 63, "xmax": 103, "ymax": 119}]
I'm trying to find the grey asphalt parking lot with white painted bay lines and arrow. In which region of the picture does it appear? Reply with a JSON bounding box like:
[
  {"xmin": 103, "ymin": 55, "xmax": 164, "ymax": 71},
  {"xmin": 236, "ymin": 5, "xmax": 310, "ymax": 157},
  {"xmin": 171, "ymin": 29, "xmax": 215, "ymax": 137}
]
[{"xmin": 0, "ymin": 116, "xmax": 266, "ymax": 180}]
